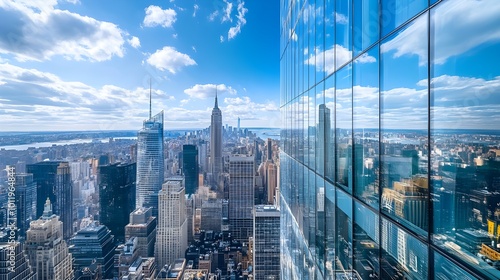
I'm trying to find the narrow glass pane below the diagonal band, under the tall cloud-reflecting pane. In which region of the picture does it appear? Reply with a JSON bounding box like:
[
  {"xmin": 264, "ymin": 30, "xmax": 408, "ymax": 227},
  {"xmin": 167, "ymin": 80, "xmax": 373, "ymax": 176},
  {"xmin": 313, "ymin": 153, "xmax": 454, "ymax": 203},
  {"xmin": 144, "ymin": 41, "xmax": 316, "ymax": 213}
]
[{"xmin": 354, "ymin": 201, "xmax": 380, "ymax": 279}]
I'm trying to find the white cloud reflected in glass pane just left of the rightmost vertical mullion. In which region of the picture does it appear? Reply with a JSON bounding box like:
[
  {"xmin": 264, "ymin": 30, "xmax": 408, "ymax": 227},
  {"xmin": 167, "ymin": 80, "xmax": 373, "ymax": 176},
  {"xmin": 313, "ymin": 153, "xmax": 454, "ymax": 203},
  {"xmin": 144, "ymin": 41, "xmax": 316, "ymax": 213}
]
[{"xmin": 380, "ymin": 16, "xmax": 427, "ymax": 66}]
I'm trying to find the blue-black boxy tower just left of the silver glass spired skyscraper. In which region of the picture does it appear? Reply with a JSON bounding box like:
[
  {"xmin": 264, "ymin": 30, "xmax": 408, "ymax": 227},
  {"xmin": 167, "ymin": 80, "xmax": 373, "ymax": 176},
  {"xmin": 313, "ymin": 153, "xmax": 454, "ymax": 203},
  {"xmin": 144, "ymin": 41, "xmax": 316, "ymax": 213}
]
[{"xmin": 98, "ymin": 163, "xmax": 137, "ymax": 242}]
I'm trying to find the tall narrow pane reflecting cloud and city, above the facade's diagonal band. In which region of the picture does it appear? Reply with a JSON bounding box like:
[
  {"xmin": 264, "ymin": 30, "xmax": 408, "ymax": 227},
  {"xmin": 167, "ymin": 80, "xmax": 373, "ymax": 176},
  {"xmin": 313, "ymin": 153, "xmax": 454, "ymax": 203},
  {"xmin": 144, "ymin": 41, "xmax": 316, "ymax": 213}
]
[{"xmin": 352, "ymin": 46, "xmax": 380, "ymax": 208}]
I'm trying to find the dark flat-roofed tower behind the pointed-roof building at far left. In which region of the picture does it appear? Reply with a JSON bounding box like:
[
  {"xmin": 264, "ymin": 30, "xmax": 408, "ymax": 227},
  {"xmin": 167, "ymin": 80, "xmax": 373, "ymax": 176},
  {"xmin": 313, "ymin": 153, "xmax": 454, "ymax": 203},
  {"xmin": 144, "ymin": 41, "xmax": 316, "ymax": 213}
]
[{"xmin": 26, "ymin": 161, "xmax": 76, "ymax": 240}]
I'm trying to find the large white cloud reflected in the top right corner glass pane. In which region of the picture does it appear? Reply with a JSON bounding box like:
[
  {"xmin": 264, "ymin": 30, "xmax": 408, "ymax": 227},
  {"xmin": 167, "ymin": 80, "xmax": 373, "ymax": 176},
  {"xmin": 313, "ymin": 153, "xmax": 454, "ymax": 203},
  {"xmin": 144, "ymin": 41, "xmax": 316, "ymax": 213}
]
[{"xmin": 431, "ymin": 0, "xmax": 500, "ymax": 64}]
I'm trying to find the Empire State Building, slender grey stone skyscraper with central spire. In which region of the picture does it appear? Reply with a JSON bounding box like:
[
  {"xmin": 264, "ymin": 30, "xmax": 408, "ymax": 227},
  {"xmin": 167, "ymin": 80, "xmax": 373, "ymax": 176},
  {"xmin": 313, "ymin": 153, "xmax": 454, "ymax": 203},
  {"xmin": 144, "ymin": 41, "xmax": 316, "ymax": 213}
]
[{"xmin": 210, "ymin": 92, "xmax": 223, "ymax": 188}]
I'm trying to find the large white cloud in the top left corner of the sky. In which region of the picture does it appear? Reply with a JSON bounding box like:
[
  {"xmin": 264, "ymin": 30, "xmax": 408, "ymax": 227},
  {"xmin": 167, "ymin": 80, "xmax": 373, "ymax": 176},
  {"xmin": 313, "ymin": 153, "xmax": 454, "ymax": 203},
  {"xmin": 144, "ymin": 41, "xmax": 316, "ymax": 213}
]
[{"xmin": 0, "ymin": 1, "xmax": 126, "ymax": 61}]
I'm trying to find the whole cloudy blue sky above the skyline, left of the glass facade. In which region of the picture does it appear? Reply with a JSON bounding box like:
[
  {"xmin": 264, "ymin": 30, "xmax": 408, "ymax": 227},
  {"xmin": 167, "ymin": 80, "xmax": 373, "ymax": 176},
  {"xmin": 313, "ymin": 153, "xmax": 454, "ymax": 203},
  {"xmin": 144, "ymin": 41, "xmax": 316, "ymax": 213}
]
[{"xmin": 0, "ymin": 0, "xmax": 280, "ymax": 131}]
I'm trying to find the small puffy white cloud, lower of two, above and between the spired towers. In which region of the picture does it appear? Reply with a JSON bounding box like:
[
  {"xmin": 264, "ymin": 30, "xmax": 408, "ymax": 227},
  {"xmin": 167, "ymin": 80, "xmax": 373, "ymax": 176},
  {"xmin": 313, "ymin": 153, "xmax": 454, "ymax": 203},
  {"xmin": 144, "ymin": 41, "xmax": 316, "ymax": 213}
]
[{"xmin": 146, "ymin": 46, "xmax": 196, "ymax": 74}]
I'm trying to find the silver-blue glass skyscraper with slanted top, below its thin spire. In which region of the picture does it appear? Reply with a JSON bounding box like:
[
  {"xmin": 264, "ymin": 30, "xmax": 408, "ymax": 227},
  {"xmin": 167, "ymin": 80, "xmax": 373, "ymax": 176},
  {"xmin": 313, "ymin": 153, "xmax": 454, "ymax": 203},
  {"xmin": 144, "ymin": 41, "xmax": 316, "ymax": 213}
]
[{"xmin": 135, "ymin": 111, "xmax": 164, "ymax": 216}]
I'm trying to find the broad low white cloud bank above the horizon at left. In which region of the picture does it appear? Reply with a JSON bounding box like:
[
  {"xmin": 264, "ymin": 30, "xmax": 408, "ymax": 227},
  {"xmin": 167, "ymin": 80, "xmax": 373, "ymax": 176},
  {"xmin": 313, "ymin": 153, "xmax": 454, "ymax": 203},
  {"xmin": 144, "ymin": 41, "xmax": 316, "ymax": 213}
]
[{"xmin": 0, "ymin": 63, "xmax": 173, "ymax": 130}]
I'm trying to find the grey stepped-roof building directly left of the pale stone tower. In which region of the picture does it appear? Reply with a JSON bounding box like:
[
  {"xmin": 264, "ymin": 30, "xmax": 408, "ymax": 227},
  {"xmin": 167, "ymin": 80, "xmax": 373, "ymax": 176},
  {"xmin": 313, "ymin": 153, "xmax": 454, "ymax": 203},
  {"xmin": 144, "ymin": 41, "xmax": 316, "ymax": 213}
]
[{"xmin": 125, "ymin": 208, "xmax": 157, "ymax": 258}]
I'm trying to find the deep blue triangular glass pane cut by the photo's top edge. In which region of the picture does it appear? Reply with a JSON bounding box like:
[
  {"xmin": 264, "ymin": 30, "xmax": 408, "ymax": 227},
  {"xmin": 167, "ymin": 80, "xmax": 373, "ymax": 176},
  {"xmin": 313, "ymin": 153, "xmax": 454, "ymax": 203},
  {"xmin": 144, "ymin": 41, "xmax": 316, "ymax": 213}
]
[{"xmin": 381, "ymin": 0, "xmax": 428, "ymax": 36}]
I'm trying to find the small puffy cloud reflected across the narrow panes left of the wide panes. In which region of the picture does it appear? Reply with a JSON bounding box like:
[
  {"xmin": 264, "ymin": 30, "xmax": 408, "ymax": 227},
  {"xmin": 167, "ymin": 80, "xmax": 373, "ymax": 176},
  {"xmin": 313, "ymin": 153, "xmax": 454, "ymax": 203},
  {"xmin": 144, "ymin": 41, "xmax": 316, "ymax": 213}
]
[{"xmin": 304, "ymin": 45, "xmax": 377, "ymax": 73}]
